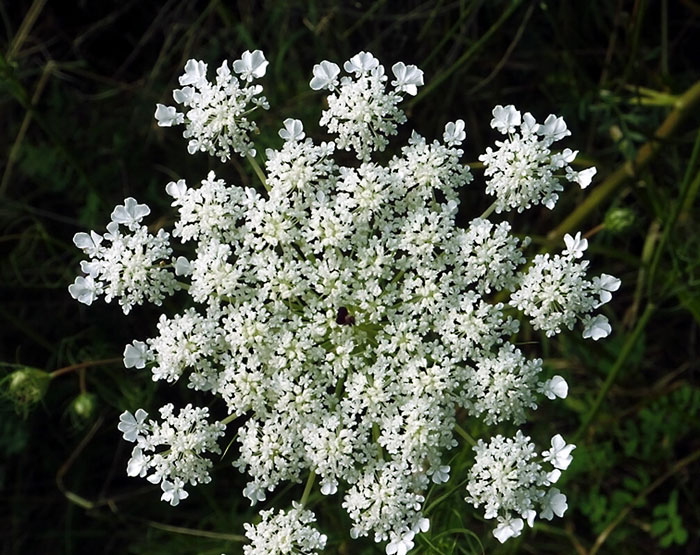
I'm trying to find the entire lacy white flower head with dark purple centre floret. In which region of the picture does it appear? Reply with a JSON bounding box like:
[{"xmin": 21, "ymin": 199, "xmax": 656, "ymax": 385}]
[{"xmin": 71, "ymin": 51, "xmax": 620, "ymax": 555}]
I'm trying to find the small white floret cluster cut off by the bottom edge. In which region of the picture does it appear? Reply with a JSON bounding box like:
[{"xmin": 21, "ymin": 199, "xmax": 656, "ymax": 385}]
[{"xmin": 243, "ymin": 501, "xmax": 327, "ymax": 555}]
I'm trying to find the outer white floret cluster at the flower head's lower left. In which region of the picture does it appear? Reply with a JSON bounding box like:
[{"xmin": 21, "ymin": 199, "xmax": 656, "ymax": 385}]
[{"xmin": 118, "ymin": 404, "xmax": 226, "ymax": 506}]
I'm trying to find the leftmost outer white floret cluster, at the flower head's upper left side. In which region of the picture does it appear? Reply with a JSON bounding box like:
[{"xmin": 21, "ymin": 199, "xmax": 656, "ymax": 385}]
[{"xmin": 68, "ymin": 197, "xmax": 178, "ymax": 314}]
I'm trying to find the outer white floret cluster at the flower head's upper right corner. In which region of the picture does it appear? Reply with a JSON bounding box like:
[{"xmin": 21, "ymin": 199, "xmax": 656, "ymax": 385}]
[{"xmin": 479, "ymin": 106, "xmax": 596, "ymax": 213}]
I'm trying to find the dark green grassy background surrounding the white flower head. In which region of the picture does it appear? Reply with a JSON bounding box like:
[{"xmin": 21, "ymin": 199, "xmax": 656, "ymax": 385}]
[{"xmin": 0, "ymin": 0, "xmax": 700, "ymax": 554}]
